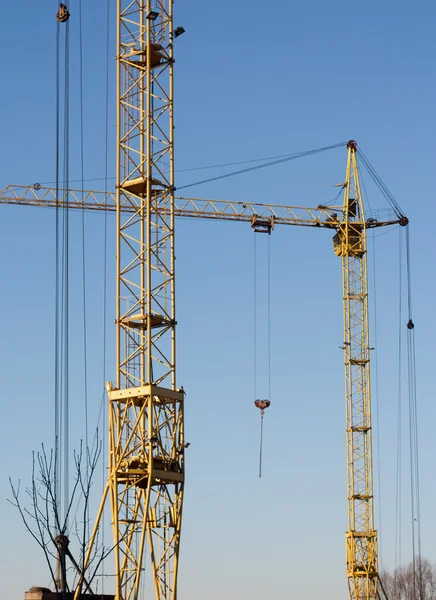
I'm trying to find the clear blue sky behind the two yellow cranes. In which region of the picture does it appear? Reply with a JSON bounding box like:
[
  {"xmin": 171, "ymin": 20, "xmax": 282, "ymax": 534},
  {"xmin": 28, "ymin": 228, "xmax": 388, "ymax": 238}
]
[{"xmin": 0, "ymin": 0, "xmax": 436, "ymax": 600}]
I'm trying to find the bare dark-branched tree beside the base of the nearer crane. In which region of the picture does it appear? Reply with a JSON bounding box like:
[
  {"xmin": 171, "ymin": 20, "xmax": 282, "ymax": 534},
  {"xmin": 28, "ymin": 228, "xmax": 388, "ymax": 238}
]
[{"xmin": 9, "ymin": 439, "xmax": 113, "ymax": 596}]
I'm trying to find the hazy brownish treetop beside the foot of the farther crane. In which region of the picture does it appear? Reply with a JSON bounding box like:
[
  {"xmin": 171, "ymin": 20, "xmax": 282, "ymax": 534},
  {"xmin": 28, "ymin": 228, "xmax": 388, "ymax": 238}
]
[{"xmin": 380, "ymin": 557, "xmax": 436, "ymax": 600}]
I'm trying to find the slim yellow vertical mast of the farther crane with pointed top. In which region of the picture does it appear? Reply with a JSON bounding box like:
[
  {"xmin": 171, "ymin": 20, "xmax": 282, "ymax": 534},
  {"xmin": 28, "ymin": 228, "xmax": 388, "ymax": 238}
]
[{"xmin": 334, "ymin": 141, "xmax": 378, "ymax": 600}]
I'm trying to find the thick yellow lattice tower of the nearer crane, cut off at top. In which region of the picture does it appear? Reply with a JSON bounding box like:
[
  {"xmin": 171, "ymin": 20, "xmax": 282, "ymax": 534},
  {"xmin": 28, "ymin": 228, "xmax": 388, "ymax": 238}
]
[{"xmin": 108, "ymin": 0, "xmax": 185, "ymax": 600}]
